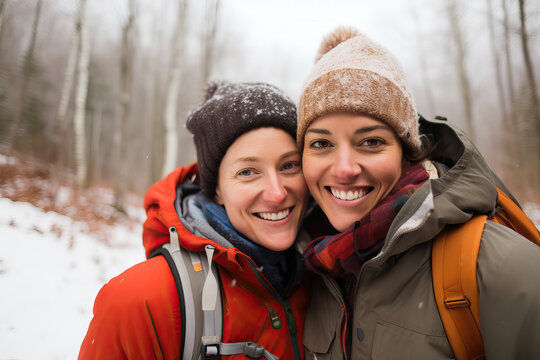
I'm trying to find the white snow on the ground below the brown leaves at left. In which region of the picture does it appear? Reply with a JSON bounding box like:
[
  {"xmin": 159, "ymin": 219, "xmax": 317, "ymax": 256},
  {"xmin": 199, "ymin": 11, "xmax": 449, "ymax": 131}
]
[{"xmin": 0, "ymin": 198, "xmax": 144, "ymax": 360}]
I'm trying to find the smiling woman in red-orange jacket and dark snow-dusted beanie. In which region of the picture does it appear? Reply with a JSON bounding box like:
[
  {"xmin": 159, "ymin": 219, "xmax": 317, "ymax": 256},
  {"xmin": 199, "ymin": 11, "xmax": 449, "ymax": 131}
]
[{"xmin": 79, "ymin": 83, "xmax": 309, "ymax": 359}]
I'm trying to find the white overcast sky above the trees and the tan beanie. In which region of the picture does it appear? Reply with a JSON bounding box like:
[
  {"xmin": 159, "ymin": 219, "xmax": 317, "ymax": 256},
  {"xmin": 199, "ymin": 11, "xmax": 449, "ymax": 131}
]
[{"xmin": 83, "ymin": 0, "xmax": 442, "ymax": 100}]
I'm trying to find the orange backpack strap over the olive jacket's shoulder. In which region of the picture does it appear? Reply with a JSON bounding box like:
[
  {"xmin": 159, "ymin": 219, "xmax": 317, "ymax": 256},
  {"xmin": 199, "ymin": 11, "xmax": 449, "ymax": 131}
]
[{"xmin": 432, "ymin": 215, "xmax": 487, "ymax": 360}]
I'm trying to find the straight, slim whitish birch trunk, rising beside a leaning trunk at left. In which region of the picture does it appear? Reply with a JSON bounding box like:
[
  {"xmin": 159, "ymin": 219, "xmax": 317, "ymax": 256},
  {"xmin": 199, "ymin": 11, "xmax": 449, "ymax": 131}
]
[{"xmin": 73, "ymin": 0, "xmax": 90, "ymax": 189}]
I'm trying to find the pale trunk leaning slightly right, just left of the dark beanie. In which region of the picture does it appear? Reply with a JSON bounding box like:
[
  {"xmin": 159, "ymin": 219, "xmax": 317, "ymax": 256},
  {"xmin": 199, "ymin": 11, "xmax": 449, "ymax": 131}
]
[{"xmin": 161, "ymin": 0, "xmax": 187, "ymax": 176}]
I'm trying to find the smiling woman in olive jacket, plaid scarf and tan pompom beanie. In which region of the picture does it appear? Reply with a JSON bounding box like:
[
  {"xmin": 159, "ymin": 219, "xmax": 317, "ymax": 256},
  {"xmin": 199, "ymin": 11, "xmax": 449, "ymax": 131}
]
[{"xmin": 297, "ymin": 29, "xmax": 540, "ymax": 359}]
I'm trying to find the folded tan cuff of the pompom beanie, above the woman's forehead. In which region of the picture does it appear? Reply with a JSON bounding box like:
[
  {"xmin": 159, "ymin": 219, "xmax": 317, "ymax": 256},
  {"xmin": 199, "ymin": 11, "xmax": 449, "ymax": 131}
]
[{"xmin": 297, "ymin": 68, "xmax": 422, "ymax": 149}]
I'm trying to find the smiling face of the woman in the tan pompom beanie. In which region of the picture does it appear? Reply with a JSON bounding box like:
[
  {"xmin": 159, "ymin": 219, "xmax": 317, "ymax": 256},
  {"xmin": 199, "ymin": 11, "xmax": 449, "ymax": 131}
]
[{"xmin": 302, "ymin": 113, "xmax": 403, "ymax": 231}]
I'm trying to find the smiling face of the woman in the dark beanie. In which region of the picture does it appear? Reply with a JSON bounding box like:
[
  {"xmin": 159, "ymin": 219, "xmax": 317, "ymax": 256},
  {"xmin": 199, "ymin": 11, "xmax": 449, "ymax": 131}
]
[{"xmin": 215, "ymin": 127, "xmax": 307, "ymax": 251}]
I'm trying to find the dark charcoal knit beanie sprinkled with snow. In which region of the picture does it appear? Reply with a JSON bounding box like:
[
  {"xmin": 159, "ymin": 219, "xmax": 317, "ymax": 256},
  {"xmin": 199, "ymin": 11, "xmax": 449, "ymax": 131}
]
[{"xmin": 186, "ymin": 82, "xmax": 297, "ymax": 198}]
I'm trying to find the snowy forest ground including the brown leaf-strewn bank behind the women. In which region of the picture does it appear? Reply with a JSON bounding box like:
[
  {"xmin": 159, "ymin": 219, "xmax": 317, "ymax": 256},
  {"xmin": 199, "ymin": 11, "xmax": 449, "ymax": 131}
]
[{"xmin": 0, "ymin": 155, "xmax": 540, "ymax": 360}]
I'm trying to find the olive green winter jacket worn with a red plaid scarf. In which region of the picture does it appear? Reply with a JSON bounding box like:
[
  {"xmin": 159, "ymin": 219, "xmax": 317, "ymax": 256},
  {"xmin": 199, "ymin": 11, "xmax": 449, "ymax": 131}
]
[{"xmin": 304, "ymin": 120, "xmax": 540, "ymax": 359}]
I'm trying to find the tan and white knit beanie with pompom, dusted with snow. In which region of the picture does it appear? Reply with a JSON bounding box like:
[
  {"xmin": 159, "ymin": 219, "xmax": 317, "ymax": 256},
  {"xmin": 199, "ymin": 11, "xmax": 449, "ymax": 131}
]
[{"xmin": 297, "ymin": 28, "xmax": 421, "ymax": 149}]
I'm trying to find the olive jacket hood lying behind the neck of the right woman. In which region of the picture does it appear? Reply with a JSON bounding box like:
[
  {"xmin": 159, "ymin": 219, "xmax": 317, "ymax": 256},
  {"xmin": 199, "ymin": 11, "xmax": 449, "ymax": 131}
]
[{"xmin": 377, "ymin": 118, "xmax": 502, "ymax": 257}]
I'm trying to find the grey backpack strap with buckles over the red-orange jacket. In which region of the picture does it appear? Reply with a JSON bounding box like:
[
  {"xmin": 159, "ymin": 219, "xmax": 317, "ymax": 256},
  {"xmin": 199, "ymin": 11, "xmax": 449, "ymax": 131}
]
[{"xmin": 150, "ymin": 226, "xmax": 278, "ymax": 360}]
